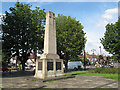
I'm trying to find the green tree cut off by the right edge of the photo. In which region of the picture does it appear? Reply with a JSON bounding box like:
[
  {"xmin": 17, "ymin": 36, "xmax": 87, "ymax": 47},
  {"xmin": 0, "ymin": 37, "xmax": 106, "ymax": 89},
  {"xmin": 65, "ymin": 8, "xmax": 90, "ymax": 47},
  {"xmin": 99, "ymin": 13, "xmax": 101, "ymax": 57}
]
[{"xmin": 100, "ymin": 18, "xmax": 120, "ymax": 58}]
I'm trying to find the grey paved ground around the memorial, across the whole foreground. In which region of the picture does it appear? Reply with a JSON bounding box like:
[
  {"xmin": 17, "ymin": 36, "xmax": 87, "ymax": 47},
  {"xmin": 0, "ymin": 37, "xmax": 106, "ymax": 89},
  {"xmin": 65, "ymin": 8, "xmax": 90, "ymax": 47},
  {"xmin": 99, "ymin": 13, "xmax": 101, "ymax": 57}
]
[{"xmin": 2, "ymin": 73, "xmax": 118, "ymax": 88}]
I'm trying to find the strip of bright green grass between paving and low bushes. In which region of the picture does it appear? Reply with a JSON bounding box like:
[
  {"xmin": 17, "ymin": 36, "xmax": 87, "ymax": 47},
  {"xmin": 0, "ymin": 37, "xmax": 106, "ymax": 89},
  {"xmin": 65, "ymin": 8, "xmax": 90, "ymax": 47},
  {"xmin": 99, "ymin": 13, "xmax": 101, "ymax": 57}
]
[{"xmin": 65, "ymin": 71, "xmax": 118, "ymax": 79}]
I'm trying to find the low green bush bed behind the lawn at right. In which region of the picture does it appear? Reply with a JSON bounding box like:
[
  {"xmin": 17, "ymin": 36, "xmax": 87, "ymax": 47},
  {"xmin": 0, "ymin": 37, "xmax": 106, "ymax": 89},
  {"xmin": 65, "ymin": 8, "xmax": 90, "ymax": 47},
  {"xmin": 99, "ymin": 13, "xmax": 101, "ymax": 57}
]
[{"xmin": 88, "ymin": 67, "xmax": 118, "ymax": 74}]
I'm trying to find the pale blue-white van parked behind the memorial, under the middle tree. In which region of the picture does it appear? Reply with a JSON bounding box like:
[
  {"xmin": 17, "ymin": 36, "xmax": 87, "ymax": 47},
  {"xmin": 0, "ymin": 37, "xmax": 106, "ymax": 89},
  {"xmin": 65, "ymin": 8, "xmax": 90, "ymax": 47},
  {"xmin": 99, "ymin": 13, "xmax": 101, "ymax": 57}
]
[{"xmin": 68, "ymin": 61, "xmax": 83, "ymax": 70}]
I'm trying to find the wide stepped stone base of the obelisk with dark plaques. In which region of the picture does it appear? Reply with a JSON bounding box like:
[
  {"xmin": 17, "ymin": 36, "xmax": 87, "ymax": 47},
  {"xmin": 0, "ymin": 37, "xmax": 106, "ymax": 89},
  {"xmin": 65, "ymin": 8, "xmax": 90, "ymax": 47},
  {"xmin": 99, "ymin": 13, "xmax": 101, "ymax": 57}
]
[{"xmin": 34, "ymin": 54, "xmax": 64, "ymax": 79}]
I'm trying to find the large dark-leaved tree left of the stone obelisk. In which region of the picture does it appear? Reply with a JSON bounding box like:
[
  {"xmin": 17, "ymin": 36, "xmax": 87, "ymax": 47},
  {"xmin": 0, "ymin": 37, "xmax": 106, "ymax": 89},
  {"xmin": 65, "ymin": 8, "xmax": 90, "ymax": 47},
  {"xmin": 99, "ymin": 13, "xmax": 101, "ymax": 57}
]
[{"xmin": 2, "ymin": 2, "xmax": 45, "ymax": 70}]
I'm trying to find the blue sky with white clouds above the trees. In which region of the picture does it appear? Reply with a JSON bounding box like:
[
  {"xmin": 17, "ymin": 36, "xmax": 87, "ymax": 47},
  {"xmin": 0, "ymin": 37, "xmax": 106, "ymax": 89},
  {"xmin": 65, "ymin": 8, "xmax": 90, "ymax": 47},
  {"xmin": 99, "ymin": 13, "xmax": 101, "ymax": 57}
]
[{"xmin": 0, "ymin": 0, "xmax": 118, "ymax": 55}]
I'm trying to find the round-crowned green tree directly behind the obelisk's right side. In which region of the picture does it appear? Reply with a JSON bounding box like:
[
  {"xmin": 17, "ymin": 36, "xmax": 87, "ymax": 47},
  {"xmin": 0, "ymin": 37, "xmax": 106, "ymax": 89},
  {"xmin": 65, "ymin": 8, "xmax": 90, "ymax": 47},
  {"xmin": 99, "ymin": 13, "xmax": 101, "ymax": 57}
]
[{"xmin": 56, "ymin": 14, "xmax": 86, "ymax": 71}]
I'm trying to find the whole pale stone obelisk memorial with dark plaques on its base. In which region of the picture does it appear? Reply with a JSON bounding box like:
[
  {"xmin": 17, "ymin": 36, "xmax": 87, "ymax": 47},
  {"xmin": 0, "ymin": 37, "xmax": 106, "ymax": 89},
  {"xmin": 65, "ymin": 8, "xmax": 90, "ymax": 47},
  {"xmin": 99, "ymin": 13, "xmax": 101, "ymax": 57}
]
[{"xmin": 35, "ymin": 11, "xmax": 64, "ymax": 79}]
